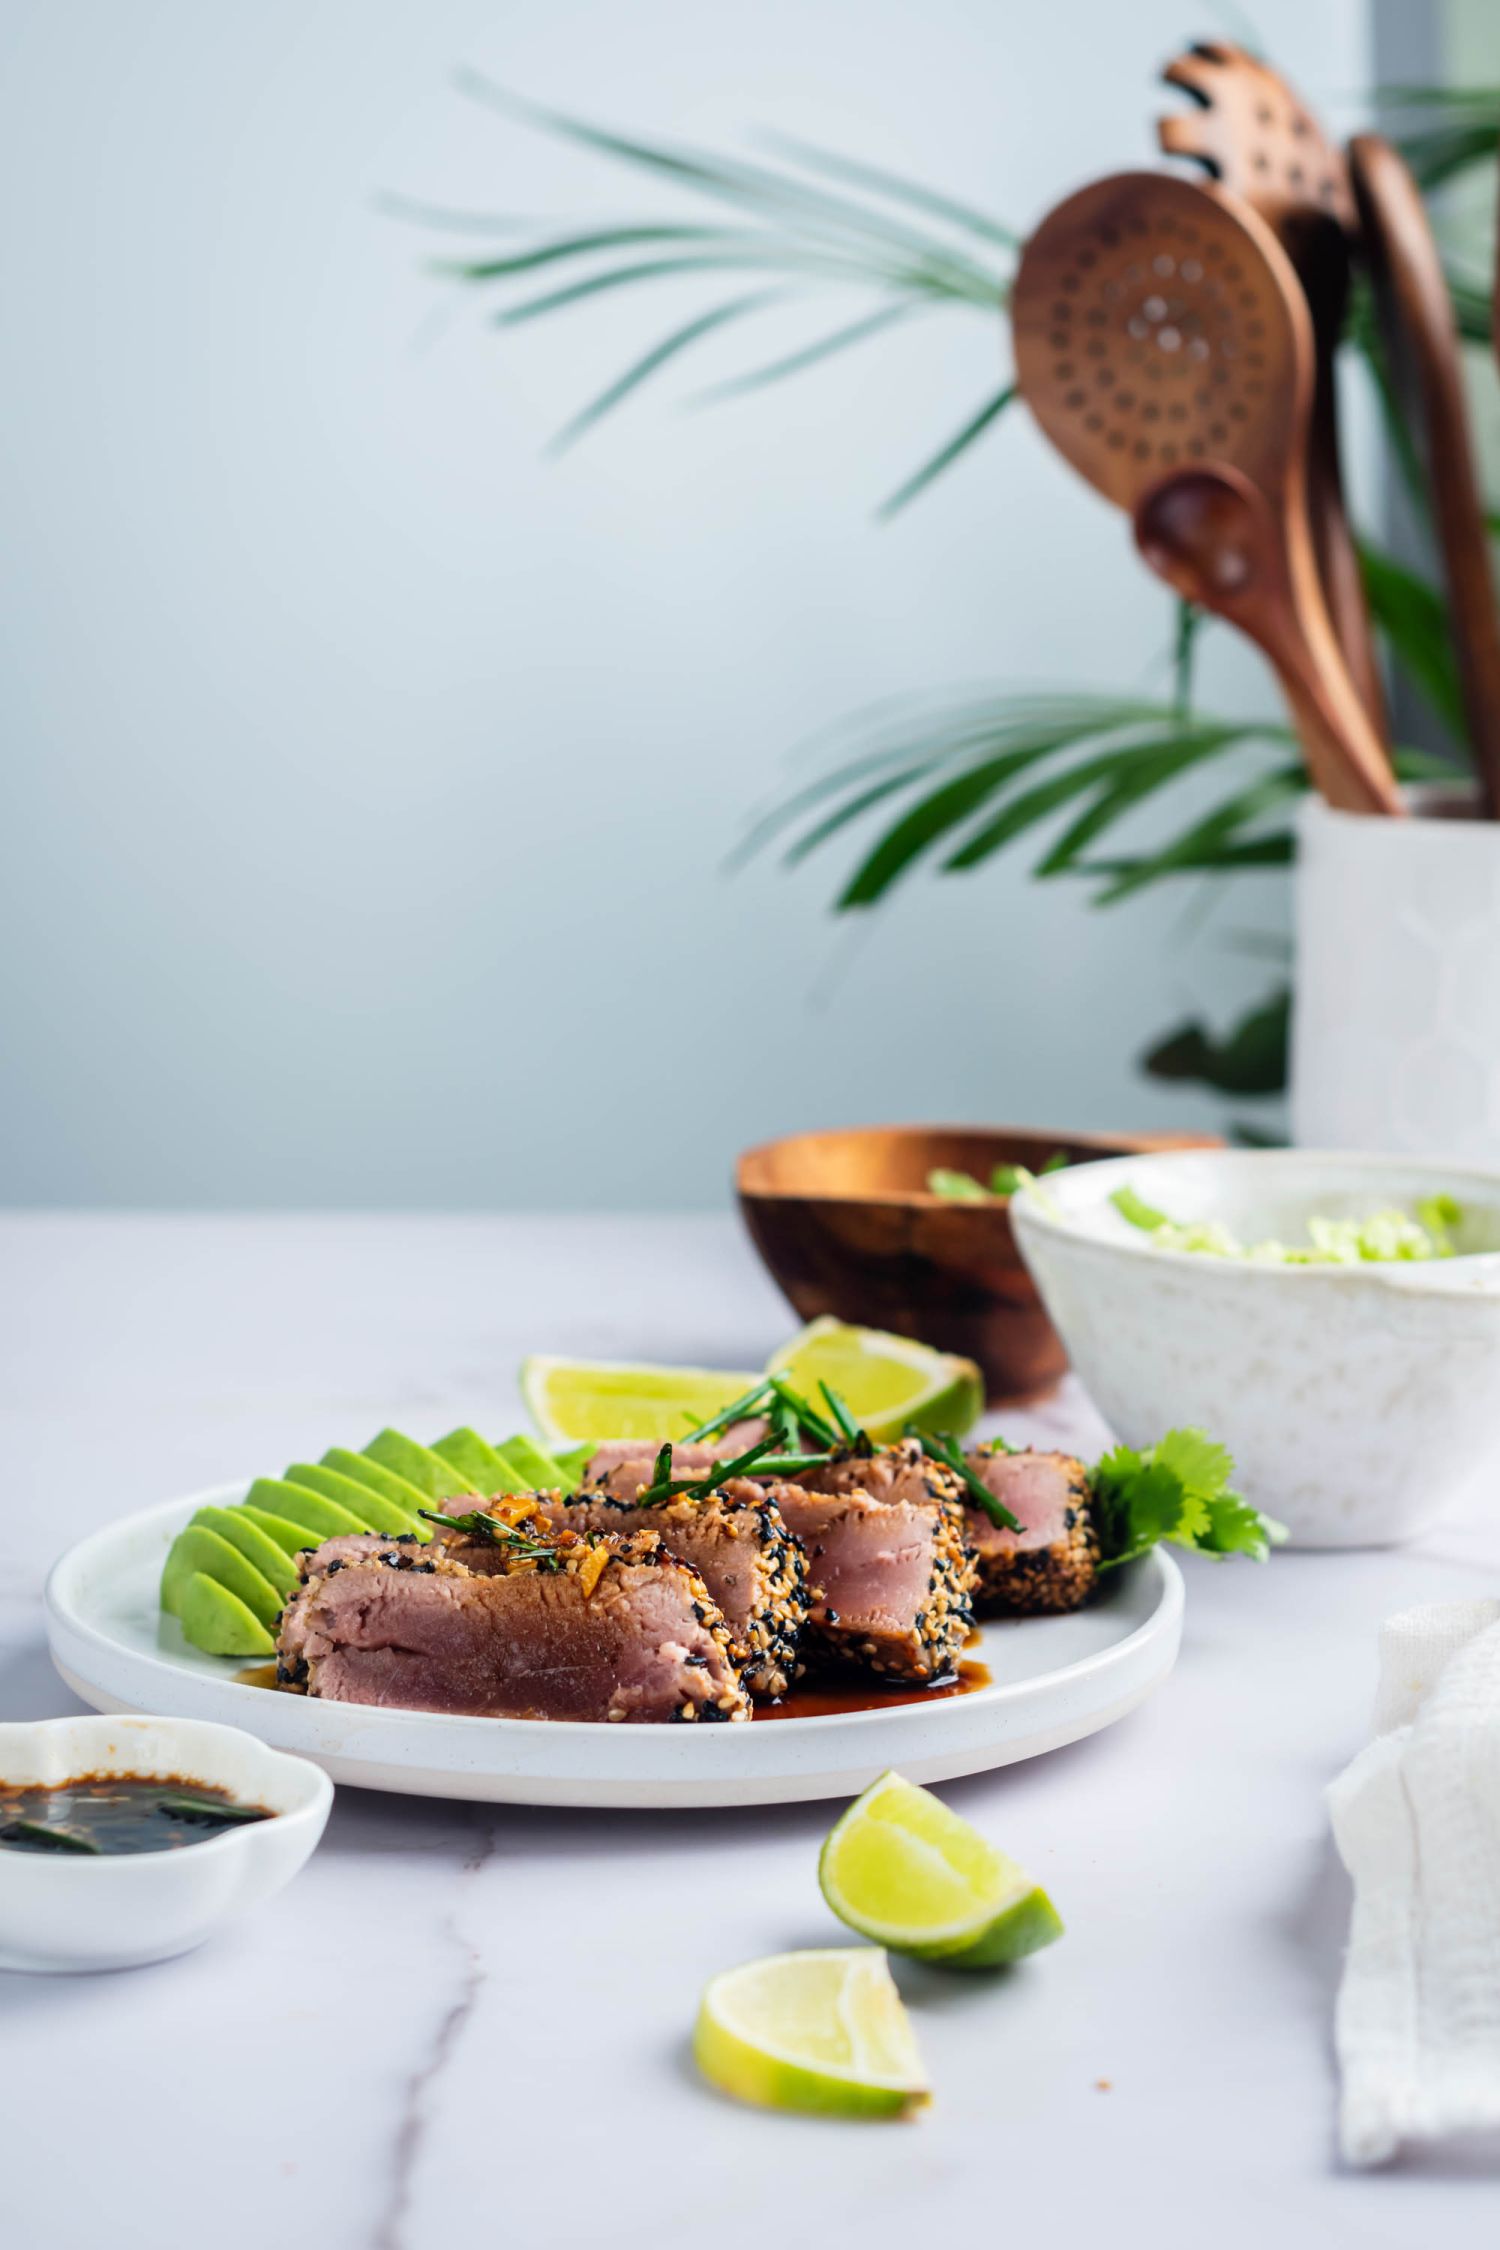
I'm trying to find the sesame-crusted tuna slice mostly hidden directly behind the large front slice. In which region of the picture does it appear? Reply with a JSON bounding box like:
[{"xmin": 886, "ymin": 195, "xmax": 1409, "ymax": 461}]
[{"xmin": 542, "ymin": 1476, "xmax": 810, "ymax": 1694}]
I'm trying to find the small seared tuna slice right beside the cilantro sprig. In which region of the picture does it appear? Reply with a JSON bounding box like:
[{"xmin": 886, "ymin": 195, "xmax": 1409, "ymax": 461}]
[{"xmin": 965, "ymin": 1451, "xmax": 1100, "ymax": 1616}]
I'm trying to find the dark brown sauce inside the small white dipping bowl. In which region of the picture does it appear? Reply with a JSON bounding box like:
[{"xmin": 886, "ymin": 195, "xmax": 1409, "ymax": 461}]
[{"xmin": 0, "ymin": 1773, "xmax": 274, "ymax": 1859}]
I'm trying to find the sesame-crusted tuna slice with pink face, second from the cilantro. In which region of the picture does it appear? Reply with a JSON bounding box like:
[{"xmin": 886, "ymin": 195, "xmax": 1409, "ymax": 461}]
[{"xmin": 771, "ymin": 1463, "xmax": 974, "ymax": 1681}]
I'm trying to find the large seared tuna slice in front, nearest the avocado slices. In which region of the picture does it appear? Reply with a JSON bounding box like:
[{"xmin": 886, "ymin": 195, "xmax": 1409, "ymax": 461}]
[{"xmin": 279, "ymin": 1519, "xmax": 749, "ymax": 1721}]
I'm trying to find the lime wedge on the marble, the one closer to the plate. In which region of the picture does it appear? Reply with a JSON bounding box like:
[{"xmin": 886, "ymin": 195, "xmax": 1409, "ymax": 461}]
[{"xmin": 819, "ymin": 1773, "xmax": 1061, "ymax": 1969}]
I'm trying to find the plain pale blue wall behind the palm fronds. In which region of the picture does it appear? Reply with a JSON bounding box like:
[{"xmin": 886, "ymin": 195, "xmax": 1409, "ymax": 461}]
[{"xmin": 0, "ymin": 0, "xmax": 1367, "ymax": 1206}]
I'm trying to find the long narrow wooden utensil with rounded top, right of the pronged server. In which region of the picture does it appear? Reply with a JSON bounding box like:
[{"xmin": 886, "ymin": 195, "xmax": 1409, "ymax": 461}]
[{"xmin": 1349, "ymin": 133, "xmax": 1500, "ymax": 819}]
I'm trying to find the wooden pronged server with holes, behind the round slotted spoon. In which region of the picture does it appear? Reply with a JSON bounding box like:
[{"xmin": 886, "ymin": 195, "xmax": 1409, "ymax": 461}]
[{"xmin": 1156, "ymin": 38, "xmax": 1385, "ymax": 734}]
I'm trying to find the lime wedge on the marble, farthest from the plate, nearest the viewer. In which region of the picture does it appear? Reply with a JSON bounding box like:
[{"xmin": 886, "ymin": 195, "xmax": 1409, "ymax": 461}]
[{"xmin": 693, "ymin": 1946, "xmax": 929, "ymax": 2117}]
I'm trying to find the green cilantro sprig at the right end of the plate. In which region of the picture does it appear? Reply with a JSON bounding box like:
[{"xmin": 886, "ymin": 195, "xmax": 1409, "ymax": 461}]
[{"xmin": 1091, "ymin": 1429, "xmax": 1286, "ymax": 1571}]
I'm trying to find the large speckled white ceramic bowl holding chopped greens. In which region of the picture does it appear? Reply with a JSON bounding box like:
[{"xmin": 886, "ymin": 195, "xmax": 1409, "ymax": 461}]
[{"xmin": 1012, "ymin": 1150, "xmax": 1500, "ymax": 1546}]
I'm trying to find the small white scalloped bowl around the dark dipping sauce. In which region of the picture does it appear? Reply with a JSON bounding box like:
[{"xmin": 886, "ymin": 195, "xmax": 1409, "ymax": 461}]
[{"xmin": 0, "ymin": 1717, "xmax": 333, "ymax": 1971}]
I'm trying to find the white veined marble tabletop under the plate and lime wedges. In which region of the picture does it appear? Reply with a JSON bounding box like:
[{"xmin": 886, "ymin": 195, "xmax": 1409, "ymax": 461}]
[{"xmin": 0, "ymin": 1215, "xmax": 1500, "ymax": 2250}]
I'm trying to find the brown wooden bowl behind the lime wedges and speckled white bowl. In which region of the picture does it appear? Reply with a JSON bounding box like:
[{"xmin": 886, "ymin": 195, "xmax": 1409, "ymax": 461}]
[{"xmin": 735, "ymin": 1125, "xmax": 1221, "ymax": 1402}]
